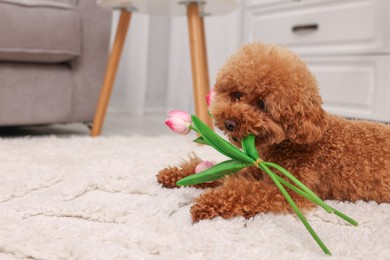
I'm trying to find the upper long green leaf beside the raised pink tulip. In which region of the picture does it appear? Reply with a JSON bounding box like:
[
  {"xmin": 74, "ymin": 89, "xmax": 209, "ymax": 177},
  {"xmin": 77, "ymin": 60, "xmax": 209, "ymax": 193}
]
[{"xmin": 192, "ymin": 115, "xmax": 255, "ymax": 164}]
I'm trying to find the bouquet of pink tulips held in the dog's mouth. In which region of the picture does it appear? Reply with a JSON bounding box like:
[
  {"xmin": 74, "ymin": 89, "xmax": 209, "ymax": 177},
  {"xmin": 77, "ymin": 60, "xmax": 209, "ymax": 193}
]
[{"xmin": 165, "ymin": 108, "xmax": 358, "ymax": 255}]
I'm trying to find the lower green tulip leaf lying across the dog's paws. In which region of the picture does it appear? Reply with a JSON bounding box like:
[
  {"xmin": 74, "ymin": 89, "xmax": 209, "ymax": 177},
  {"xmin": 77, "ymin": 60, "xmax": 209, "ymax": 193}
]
[{"xmin": 176, "ymin": 160, "xmax": 248, "ymax": 186}]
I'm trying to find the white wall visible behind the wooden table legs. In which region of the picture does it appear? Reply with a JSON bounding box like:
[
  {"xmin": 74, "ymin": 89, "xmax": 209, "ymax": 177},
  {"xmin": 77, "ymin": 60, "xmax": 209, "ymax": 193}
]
[{"xmin": 109, "ymin": 3, "xmax": 241, "ymax": 114}]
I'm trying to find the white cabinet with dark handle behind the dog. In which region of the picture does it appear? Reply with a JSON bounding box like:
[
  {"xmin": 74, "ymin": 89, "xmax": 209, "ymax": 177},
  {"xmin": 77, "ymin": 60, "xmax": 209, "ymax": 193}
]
[{"xmin": 243, "ymin": 0, "xmax": 390, "ymax": 121}]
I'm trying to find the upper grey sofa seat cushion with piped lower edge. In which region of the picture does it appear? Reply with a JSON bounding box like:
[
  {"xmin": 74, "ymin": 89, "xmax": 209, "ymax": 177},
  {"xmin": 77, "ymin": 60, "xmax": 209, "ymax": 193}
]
[{"xmin": 0, "ymin": 0, "xmax": 81, "ymax": 63}]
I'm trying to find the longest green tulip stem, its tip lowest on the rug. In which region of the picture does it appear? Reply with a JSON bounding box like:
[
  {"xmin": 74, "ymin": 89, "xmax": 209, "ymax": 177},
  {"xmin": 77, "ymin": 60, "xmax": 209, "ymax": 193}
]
[{"xmin": 260, "ymin": 163, "xmax": 332, "ymax": 255}]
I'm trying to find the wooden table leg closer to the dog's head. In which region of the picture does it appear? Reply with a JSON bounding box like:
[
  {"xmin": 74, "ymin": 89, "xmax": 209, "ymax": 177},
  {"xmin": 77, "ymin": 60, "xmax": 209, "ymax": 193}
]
[{"xmin": 187, "ymin": 2, "xmax": 212, "ymax": 128}]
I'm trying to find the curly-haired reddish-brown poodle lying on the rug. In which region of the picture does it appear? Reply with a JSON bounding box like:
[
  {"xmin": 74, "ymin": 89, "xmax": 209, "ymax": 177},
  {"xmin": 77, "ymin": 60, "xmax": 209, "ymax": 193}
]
[{"xmin": 158, "ymin": 43, "xmax": 390, "ymax": 222}]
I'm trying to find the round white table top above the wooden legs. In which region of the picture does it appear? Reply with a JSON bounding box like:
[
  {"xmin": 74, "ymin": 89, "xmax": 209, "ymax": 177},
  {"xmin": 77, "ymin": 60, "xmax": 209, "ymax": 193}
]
[{"xmin": 97, "ymin": 0, "xmax": 239, "ymax": 15}]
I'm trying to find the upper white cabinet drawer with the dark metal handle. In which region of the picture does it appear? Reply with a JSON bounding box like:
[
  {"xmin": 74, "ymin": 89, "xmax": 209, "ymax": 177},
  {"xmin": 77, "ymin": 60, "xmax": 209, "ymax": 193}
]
[{"xmin": 244, "ymin": 0, "xmax": 390, "ymax": 55}]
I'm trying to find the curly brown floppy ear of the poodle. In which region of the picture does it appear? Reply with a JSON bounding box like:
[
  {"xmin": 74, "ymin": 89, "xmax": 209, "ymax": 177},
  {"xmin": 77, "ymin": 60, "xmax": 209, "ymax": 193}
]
[{"xmin": 270, "ymin": 84, "xmax": 327, "ymax": 144}]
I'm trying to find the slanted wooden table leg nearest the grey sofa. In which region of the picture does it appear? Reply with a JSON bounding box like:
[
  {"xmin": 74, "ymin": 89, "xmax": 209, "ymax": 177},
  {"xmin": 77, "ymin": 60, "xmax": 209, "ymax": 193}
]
[{"xmin": 90, "ymin": 9, "xmax": 131, "ymax": 136}]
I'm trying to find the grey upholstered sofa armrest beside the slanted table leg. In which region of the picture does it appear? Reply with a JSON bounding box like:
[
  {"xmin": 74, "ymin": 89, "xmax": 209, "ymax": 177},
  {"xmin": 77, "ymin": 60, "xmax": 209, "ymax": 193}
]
[{"xmin": 69, "ymin": 0, "xmax": 112, "ymax": 122}]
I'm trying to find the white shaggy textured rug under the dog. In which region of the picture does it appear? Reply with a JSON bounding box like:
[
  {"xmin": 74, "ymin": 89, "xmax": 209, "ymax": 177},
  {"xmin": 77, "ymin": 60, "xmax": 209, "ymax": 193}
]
[{"xmin": 0, "ymin": 136, "xmax": 390, "ymax": 259}]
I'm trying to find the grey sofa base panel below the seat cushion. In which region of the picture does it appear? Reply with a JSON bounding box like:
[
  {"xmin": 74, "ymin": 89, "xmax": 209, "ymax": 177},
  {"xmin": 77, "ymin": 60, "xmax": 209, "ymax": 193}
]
[{"xmin": 0, "ymin": 62, "xmax": 73, "ymax": 126}]
